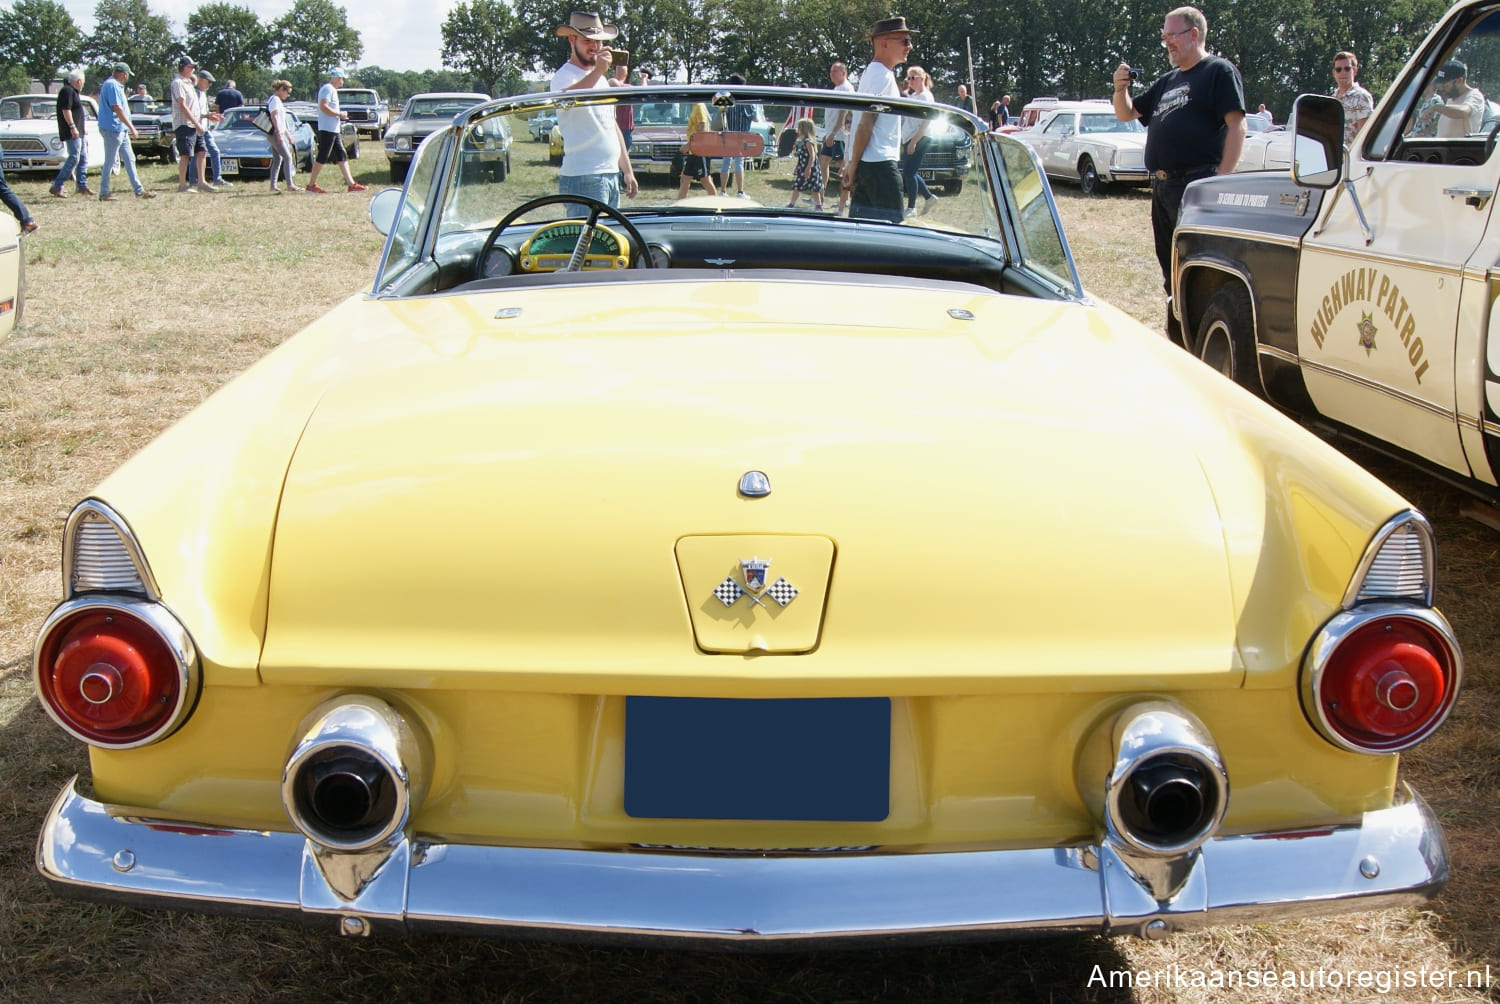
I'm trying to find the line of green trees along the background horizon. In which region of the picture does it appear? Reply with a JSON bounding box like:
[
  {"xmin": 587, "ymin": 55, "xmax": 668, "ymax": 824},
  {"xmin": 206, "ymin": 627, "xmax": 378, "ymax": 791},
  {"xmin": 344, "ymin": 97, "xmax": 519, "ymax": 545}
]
[{"xmin": 0, "ymin": 0, "xmax": 1464, "ymax": 119}]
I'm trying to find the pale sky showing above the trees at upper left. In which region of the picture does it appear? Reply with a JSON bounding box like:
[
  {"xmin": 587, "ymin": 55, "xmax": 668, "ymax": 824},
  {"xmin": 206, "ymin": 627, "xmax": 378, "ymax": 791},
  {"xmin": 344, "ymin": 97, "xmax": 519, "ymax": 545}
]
[{"xmin": 62, "ymin": 0, "xmax": 456, "ymax": 69}]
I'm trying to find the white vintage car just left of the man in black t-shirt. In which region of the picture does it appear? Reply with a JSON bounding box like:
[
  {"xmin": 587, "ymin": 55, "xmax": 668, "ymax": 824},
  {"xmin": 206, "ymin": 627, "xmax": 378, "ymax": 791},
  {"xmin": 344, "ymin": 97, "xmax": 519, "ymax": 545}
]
[{"xmin": 1016, "ymin": 101, "xmax": 1151, "ymax": 195}]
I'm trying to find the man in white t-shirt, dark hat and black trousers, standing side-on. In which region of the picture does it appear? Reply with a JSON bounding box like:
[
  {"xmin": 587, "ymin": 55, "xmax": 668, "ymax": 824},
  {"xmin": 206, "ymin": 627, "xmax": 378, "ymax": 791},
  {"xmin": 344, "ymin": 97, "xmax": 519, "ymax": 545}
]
[{"xmin": 839, "ymin": 18, "xmax": 914, "ymax": 224}]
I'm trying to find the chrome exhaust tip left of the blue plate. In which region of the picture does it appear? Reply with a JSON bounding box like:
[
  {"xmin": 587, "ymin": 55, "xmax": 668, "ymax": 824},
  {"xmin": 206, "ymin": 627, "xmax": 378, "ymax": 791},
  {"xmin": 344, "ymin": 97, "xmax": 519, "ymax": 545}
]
[{"xmin": 282, "ymin": 695, "xmax": 426, "ymax": 851}]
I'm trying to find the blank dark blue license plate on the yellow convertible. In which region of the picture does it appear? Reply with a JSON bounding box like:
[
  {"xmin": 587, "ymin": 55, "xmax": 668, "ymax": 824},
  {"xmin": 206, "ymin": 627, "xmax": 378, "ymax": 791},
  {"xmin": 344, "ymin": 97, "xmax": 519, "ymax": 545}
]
[{"xmin": 626, "ymin": 696, "xmax": 891, "ymax": 822}]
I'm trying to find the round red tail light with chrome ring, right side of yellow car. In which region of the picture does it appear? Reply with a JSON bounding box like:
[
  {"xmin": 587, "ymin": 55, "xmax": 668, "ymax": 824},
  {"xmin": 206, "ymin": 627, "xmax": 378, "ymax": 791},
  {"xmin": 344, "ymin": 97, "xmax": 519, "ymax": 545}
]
[{"xmin": 1307, "ymin": 608, "xmax": 1460, "ymax": 753}]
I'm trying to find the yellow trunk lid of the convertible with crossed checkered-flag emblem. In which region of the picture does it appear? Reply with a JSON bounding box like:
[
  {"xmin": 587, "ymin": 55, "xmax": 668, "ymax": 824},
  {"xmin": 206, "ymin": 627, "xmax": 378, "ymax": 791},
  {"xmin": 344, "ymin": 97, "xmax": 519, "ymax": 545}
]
[{"xmin": 261, "ymin": 281, "xmax": 1290, "ymax": 693}]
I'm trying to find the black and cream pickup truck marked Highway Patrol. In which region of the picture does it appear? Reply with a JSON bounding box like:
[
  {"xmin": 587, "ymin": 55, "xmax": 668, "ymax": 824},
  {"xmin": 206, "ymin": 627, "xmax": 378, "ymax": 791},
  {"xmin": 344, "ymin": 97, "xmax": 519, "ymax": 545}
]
[{"xmin": 1167, "ymin": 0, "xmax": 1500, "ymax": 506}]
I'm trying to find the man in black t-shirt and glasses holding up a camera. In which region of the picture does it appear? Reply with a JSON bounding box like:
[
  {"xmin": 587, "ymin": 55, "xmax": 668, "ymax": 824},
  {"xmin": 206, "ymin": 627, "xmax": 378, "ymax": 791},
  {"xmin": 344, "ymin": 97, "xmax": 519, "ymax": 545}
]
[{"xmin": 1115, "ymin": 8, "xmax": 1245, "ymax": 316}]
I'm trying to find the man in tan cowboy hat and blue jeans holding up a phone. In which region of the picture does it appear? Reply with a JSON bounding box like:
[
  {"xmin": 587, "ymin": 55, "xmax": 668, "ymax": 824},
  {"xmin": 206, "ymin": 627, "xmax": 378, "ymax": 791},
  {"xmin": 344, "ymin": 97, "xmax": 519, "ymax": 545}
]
[{"xmin": 552, "ymin": 11, "xmax": 639, "ymax": 216}]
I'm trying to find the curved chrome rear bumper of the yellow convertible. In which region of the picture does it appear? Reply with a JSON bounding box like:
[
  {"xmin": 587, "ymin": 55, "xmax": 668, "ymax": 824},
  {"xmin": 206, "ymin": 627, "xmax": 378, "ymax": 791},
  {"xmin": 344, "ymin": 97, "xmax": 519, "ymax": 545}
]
[{"xmin": 36, "ymin": 779, "xmax": 1448, "ymax": 947}]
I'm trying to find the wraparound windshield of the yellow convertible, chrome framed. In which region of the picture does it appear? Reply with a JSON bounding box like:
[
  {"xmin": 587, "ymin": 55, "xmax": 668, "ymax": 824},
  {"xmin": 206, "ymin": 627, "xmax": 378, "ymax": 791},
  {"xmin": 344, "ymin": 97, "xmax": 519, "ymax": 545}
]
[{"xmin": 381, "ymin": 86, "xmax": 1077, "ymax": 300}]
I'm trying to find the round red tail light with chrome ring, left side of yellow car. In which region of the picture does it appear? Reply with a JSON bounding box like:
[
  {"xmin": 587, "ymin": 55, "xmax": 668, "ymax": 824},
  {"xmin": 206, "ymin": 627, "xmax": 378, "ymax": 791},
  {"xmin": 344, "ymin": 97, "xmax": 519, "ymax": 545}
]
[{"xmin": 36, "ymin": 602, "xmax": 197, "ymax": 749}]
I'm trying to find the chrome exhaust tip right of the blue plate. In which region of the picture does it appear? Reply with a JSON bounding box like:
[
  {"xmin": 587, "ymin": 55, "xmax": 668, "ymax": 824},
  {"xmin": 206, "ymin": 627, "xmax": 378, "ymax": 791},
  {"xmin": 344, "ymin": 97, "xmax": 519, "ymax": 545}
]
[{"xmin": 1077, "ymin": 701, "xmax": 1229, "ymax": 857}]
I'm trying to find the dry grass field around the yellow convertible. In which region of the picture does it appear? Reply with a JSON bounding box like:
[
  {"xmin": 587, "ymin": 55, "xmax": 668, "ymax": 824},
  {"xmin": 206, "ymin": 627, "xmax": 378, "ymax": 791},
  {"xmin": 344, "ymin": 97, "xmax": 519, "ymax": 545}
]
[{"xmin": 0, "ymin": 135, "xmax": 1500, "ymax": 1002}]
